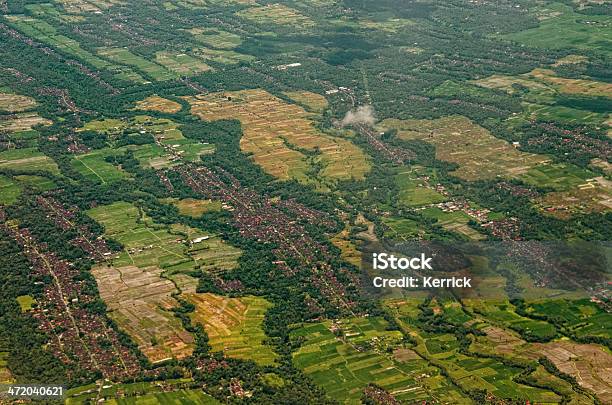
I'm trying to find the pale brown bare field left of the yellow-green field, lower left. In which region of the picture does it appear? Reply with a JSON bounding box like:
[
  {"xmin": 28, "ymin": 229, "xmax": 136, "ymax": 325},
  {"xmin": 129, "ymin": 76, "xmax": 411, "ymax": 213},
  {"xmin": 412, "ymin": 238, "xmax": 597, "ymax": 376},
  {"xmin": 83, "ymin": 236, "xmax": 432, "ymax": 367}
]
[{"xmin": 92, "ymin": 265, "xmax": 194, "ymax": 363}]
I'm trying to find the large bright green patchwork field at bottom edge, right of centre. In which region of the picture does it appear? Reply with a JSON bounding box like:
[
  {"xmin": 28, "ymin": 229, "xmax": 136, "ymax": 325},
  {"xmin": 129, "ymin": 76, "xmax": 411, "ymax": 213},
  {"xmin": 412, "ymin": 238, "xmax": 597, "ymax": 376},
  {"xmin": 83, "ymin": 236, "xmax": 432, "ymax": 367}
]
[{"xmin": 291, "ymin": 317, "xmax": 470, "ymax": 404}]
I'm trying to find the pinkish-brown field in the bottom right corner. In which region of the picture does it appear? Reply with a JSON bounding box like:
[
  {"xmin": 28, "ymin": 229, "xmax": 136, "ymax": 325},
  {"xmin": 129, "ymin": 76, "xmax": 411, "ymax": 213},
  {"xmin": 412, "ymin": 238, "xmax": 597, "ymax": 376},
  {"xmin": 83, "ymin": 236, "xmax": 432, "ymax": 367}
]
[{"xmin": 527, "ymin": 341, "xmax": 612, "ymax": 404}]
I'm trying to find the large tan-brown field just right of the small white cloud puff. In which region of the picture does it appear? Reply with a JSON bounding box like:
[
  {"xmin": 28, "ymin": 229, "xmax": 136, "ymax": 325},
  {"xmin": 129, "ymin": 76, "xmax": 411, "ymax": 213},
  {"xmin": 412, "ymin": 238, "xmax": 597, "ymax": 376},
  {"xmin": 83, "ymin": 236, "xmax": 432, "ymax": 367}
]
[{"xmin": 380, "ymin": 116, "xmax": 548, "ymax": 180}]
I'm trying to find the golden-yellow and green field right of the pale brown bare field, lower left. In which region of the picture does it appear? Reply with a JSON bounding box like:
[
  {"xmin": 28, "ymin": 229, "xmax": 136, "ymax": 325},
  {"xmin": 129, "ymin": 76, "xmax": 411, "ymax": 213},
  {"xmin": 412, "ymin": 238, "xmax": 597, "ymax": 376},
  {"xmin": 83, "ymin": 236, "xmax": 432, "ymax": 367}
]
[{"xmin": 185, "ymin": 293, "xmax": 277, "ymax": 365}]
